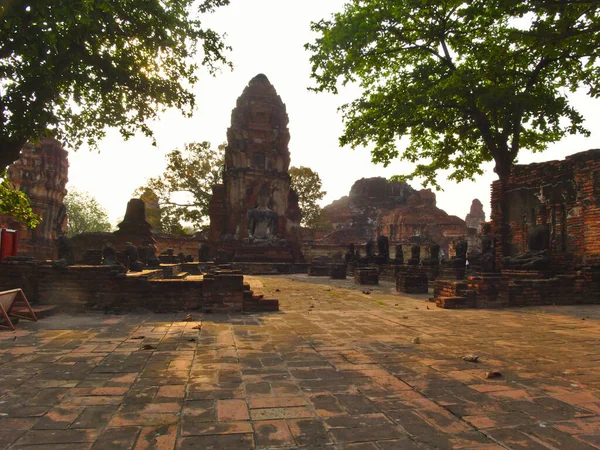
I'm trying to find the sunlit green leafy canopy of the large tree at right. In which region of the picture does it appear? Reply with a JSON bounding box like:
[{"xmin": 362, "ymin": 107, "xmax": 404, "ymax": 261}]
[{"xmin": 306, "ymin": 0, "xmax": 600, "ymax": 187}]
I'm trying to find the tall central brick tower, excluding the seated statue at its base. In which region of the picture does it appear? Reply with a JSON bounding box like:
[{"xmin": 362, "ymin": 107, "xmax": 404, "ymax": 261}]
[{"xmin": 209, "ymin": 74, "xmax": 301, "ymax": 260}]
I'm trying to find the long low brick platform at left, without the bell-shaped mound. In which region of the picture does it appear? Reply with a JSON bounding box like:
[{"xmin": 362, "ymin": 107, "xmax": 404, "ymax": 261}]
[{"xmin": 0, "ymin": 262, "xmax": 276, "ymax": 313}]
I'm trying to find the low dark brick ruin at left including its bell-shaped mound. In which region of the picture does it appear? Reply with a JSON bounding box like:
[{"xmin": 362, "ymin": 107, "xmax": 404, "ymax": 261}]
[{"xmin": 0, "ymin": 195, "xmax": 279, "ymax": 313}]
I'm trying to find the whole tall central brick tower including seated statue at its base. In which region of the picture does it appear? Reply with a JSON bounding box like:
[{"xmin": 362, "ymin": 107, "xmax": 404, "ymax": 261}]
[{"xmin": 209, "ymin": 74, "xmax": 302, "ymax": 263}]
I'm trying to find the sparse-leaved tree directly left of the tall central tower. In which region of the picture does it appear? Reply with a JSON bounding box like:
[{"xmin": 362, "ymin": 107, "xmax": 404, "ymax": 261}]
[{"xmin": 134, "ymin": 142, "xmax": 224, "ymax": 233}]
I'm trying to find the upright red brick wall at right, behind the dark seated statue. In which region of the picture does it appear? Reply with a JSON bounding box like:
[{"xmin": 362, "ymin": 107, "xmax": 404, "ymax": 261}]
[{"xmin": 491, "ymin": 150, "xmax": 600, "ymax": 272}]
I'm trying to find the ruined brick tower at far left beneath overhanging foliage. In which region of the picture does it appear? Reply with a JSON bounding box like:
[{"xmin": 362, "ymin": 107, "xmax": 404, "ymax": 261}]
[{"xmin": 0, "ymin": 138, "xmax": 69, "ymax": 259}]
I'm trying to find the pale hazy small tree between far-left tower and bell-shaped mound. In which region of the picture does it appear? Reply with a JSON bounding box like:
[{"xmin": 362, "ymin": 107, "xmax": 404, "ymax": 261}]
[{"xmin": 65, "ymin": 189, "xmax": 112, "ymax": 237}]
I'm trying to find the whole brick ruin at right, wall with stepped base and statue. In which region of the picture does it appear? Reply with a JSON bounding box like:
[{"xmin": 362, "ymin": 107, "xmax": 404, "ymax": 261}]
[{"xmin": 434, "ymin": 150, "xmax": 600, "ymax": 308}]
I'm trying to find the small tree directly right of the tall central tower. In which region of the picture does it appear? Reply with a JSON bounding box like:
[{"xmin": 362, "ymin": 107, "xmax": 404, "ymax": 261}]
[{"xmin": 289, "ymin": 166, "xmax": 327, "ymax": 228}]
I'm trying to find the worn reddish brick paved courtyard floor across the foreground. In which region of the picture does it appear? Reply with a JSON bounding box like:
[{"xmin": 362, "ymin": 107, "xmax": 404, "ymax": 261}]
[{"xmin": 0, "ymin": 276, "xmax": 600, "ymax": 450}]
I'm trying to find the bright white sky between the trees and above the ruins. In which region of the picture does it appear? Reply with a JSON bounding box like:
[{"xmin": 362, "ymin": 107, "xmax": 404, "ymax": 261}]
[{"xmin": 67, "ymin": 0, "xmax": 600, "ymax": 223}]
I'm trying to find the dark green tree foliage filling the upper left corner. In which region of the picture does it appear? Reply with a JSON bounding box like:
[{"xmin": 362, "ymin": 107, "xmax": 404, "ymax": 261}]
[{"xmin": 0, "ymin": 0, "xmax": 229, "ymax": 169}]
